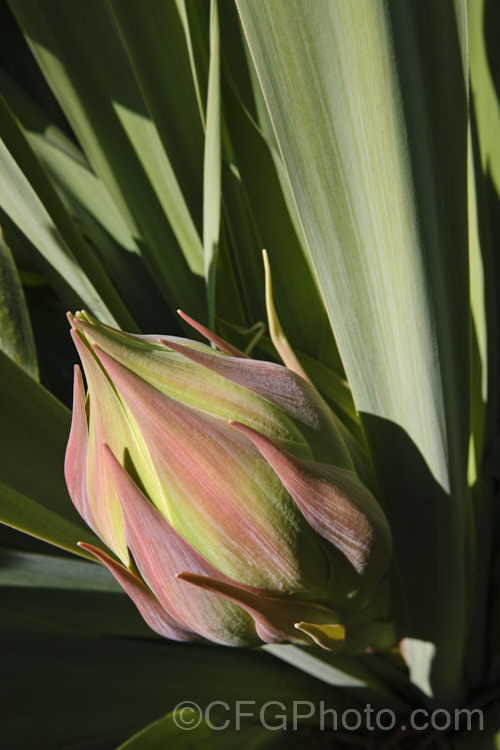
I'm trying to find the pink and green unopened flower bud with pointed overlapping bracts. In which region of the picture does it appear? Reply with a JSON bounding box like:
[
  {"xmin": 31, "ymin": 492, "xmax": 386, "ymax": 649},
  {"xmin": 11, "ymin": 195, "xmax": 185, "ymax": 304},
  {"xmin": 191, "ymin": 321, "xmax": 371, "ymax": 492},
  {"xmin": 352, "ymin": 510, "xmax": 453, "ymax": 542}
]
[{"xmin": 65, "ymin": 312, "xmax": 391, "ymax": 648}]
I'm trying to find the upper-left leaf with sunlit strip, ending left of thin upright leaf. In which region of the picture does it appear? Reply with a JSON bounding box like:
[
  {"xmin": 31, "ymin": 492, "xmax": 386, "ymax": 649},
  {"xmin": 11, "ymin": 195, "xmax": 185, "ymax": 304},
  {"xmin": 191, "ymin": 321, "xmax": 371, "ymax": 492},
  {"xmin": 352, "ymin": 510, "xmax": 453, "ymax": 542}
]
[{"xmin": 11, "ymin": 0, "xmax": 204, "ymax": 318}]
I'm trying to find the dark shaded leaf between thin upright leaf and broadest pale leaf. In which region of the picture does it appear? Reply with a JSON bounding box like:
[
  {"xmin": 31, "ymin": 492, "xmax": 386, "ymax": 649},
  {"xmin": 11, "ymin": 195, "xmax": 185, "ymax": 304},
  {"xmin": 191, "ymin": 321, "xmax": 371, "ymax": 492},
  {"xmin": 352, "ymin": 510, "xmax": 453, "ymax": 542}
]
[{"xmin": 223, "ymin": 75, "xmax": 342, "ymax": 372}]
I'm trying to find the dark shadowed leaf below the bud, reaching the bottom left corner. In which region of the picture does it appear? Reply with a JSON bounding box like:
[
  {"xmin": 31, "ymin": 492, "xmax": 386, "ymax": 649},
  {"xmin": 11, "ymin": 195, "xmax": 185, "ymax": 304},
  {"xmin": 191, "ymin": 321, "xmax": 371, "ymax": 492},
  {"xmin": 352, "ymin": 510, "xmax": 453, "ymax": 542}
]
[{"xmin": 0, "ymin": 636, "xmax": 349, "ymax": 750}]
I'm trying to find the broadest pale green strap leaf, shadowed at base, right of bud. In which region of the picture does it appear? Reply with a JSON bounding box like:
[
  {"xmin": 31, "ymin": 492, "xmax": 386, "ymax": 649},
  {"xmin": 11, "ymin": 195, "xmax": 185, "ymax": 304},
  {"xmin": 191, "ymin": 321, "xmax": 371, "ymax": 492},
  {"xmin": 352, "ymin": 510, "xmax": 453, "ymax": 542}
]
[{"xmin": 237, "ymin": 0, "xmax": 469, "ymax": 701}]
